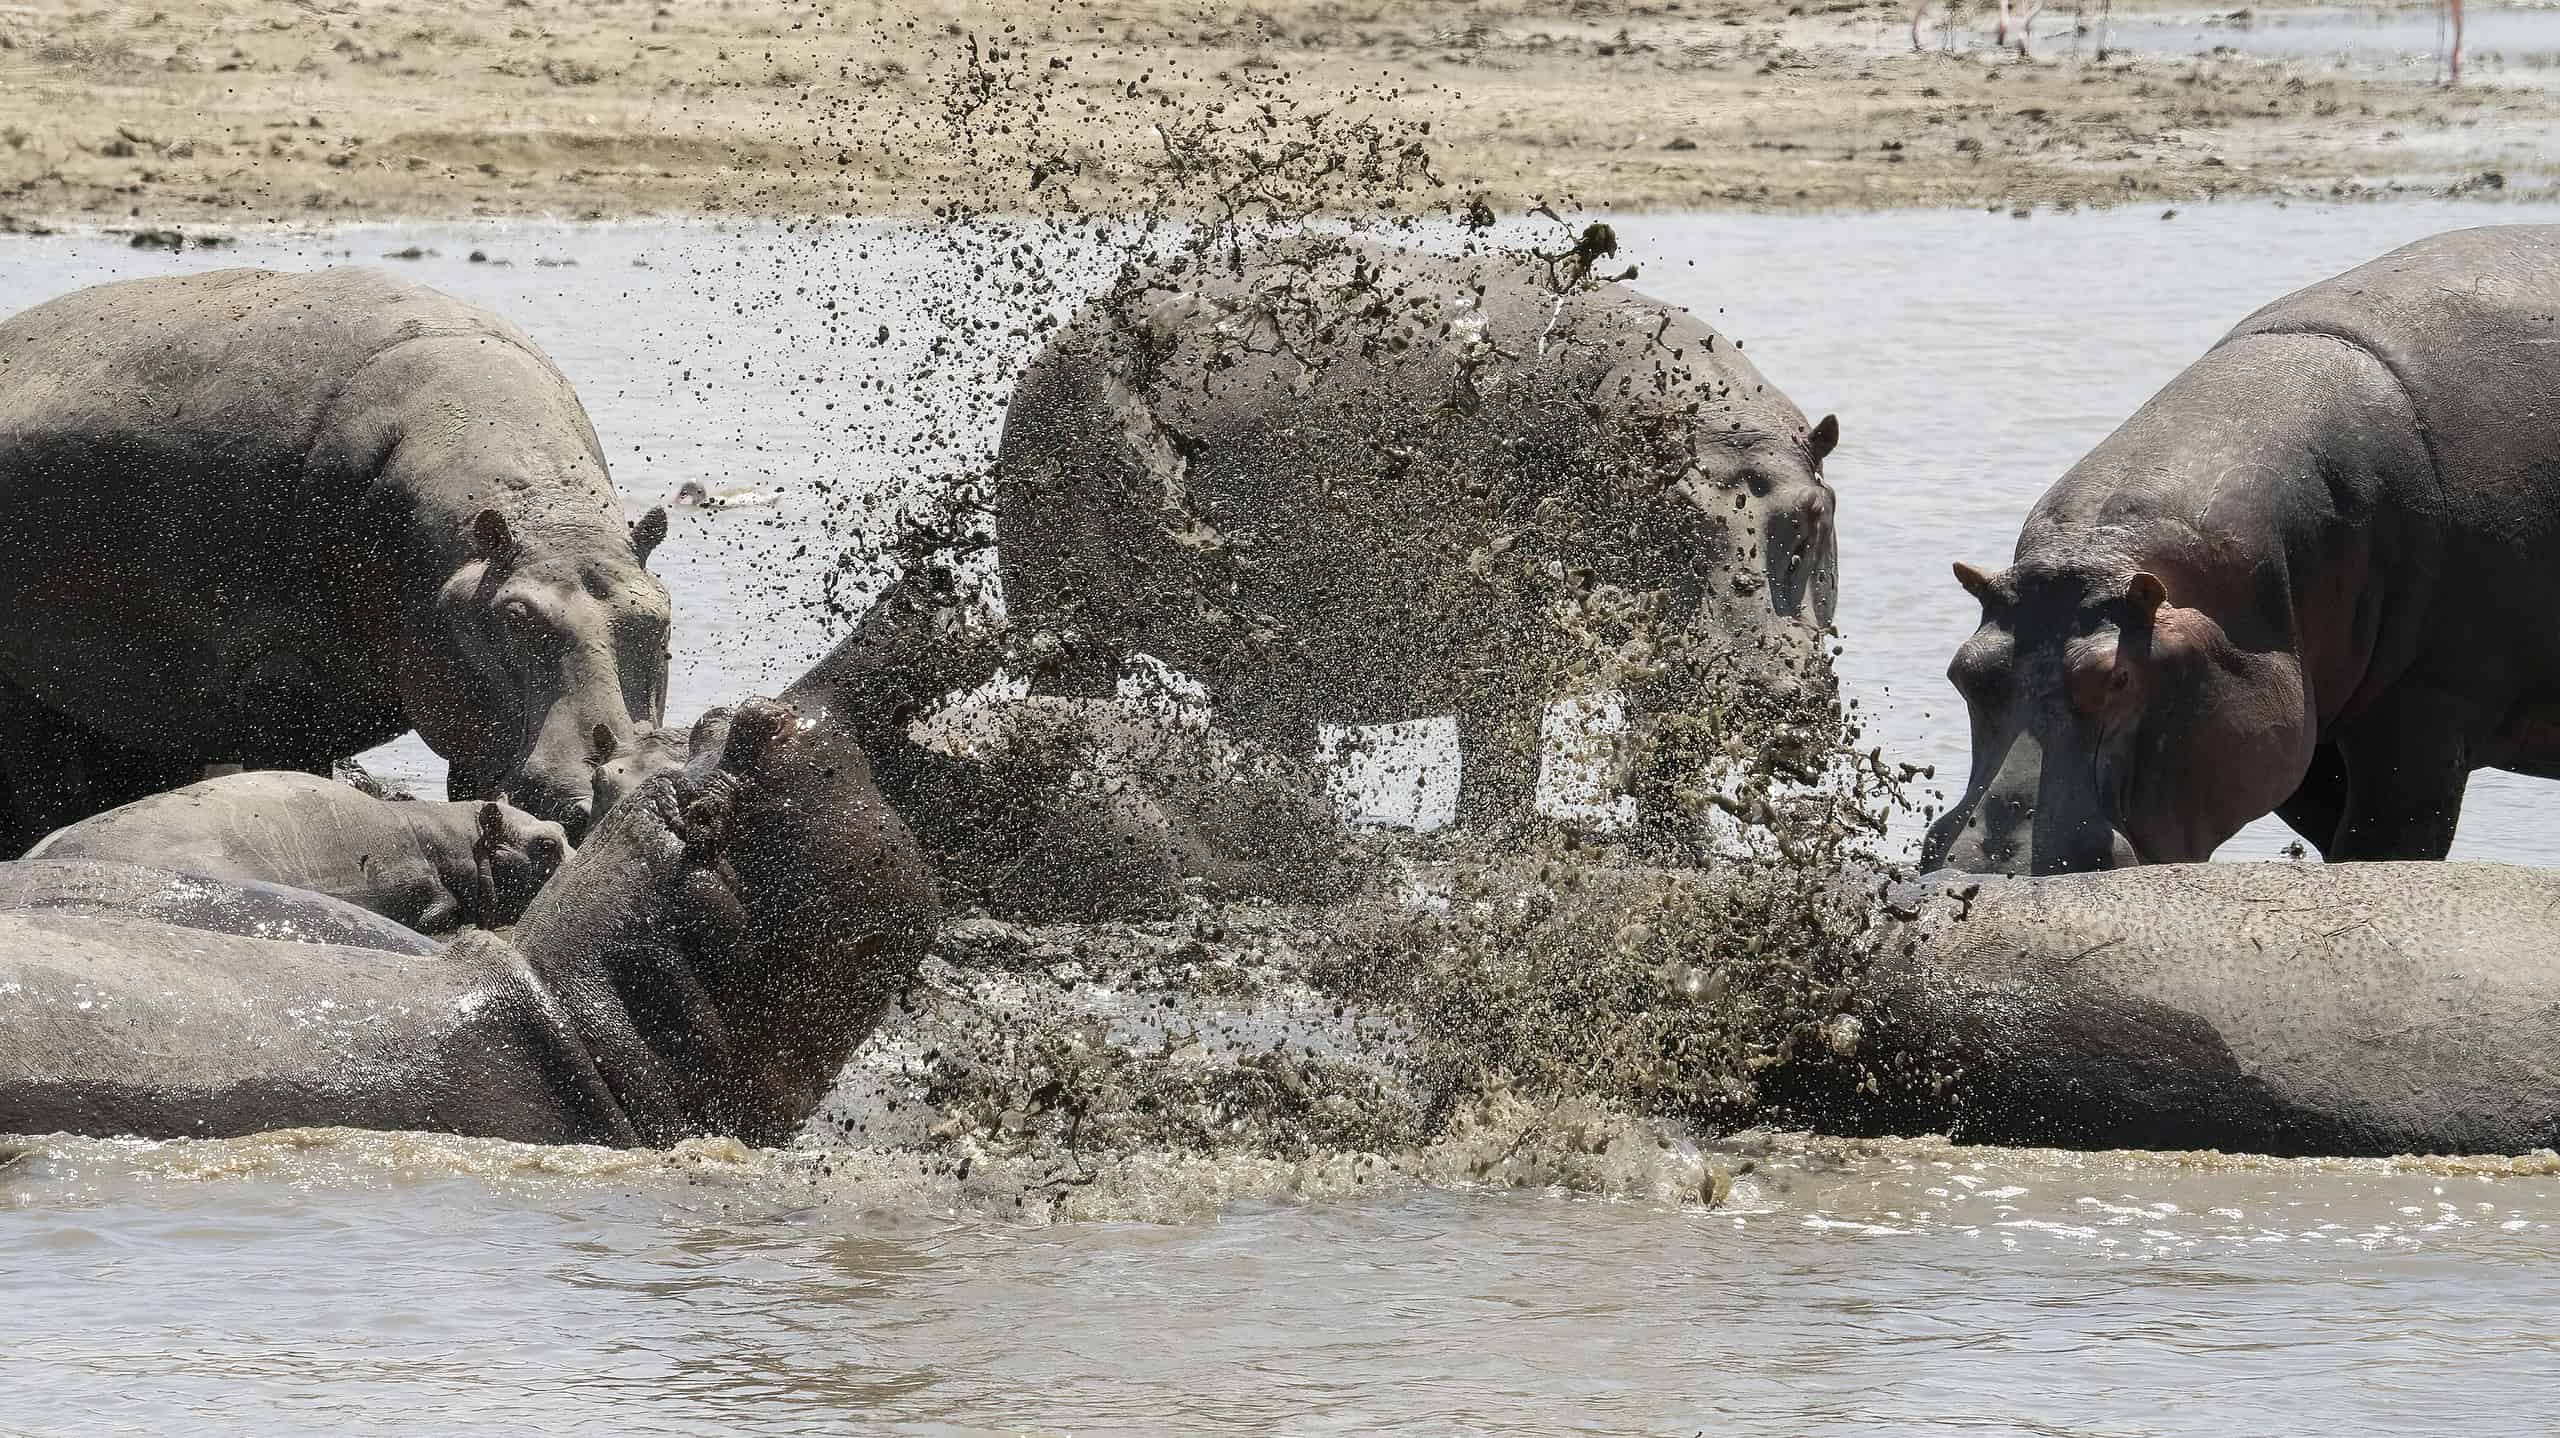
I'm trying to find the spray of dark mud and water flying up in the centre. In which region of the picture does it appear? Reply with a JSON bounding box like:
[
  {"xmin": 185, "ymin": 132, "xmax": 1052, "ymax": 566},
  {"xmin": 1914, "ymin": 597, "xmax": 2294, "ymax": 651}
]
[{"xmin": 660, "ymin": 33, "xmax": 1912, "ymax": 1213}]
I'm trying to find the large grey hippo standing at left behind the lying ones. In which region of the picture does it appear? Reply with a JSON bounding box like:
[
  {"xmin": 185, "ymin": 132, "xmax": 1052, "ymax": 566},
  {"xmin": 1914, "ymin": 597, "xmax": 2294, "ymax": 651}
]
[{"xmin": 0, "ymin": 269, "xmax": 668, "ymax": 855}]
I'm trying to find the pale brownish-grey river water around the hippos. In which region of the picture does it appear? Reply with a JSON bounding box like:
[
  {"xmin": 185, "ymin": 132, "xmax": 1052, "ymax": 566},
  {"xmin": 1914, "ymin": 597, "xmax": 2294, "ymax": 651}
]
[{"xmin": 0, "ymin": 205, "xmax": 2560, "ymax": 1435}]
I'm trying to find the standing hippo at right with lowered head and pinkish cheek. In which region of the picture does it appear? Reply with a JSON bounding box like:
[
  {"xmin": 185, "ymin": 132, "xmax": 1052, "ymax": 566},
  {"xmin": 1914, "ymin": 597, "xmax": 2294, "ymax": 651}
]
[{"xmin": 1923, "ymin": 225, "xmax": 2560, "ymax": 875}]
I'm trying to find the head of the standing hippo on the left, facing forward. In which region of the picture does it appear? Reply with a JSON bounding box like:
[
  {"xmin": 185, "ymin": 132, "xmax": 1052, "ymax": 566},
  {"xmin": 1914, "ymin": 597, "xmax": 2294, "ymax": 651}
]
[{"xmin": 402, "ymin": 509, "xmax": 668, "ymax": 837}]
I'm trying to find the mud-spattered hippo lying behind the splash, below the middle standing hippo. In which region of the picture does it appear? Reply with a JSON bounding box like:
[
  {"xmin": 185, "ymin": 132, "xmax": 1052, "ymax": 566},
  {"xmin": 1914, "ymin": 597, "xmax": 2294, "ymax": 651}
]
[{"xmin": 878, "ymin": 699, "xmax": 1349, "ymax": 921}]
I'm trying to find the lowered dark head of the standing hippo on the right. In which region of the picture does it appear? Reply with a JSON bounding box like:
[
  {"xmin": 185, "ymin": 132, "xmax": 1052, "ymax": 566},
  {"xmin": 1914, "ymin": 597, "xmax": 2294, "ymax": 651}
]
[{"xmin": 1920, "ymin": 560, "xmax": 2314, "ymax": 875}]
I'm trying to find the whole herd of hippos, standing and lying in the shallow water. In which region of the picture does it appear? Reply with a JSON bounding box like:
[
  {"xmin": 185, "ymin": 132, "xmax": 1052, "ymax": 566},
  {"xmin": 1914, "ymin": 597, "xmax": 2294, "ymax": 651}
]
[{"xmin": 0, "ymin": 225, "xmax": 2560, "ymax": 1154}]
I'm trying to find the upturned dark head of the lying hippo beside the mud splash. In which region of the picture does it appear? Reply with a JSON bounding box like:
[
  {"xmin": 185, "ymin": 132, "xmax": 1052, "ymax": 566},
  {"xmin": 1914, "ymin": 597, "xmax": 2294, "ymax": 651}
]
[{"xmin": 517, "ymin": 699, "xmax": 937, "ymax": 1144}]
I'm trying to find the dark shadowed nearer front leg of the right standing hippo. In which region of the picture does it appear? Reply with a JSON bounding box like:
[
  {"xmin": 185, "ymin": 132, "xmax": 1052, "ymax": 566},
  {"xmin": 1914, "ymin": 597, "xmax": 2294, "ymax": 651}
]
[{"xmin": 2322, "ymin": 693, "xmax": 2470, "ymax": 862}]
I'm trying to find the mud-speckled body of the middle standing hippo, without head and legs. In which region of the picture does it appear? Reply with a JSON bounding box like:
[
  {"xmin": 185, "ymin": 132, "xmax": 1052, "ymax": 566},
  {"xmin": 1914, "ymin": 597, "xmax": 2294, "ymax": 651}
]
[{"xmin": 998, "ymin": 241, "xmax": 1828, "ymax": 719}]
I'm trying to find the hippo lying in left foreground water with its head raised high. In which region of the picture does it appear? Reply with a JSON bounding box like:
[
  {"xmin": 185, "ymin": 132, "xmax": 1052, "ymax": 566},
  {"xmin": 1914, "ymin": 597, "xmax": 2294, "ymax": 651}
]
[{"xmin": 0, "ymin": 701, "xmax": 934, "ymax": 1146}]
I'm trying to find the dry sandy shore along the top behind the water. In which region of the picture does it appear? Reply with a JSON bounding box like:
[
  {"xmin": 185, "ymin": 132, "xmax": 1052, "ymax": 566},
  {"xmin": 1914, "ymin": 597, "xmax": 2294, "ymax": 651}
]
[{"xmin": 0, "ymin": 0, "xmax": 2560, "ymax": 225}]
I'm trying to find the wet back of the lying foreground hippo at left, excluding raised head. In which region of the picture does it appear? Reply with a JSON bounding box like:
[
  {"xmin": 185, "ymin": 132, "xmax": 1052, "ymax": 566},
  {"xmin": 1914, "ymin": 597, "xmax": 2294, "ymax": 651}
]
[{"xmin": 0, "ymin": 911, "xmax": 630, "ymax": 1144}]
